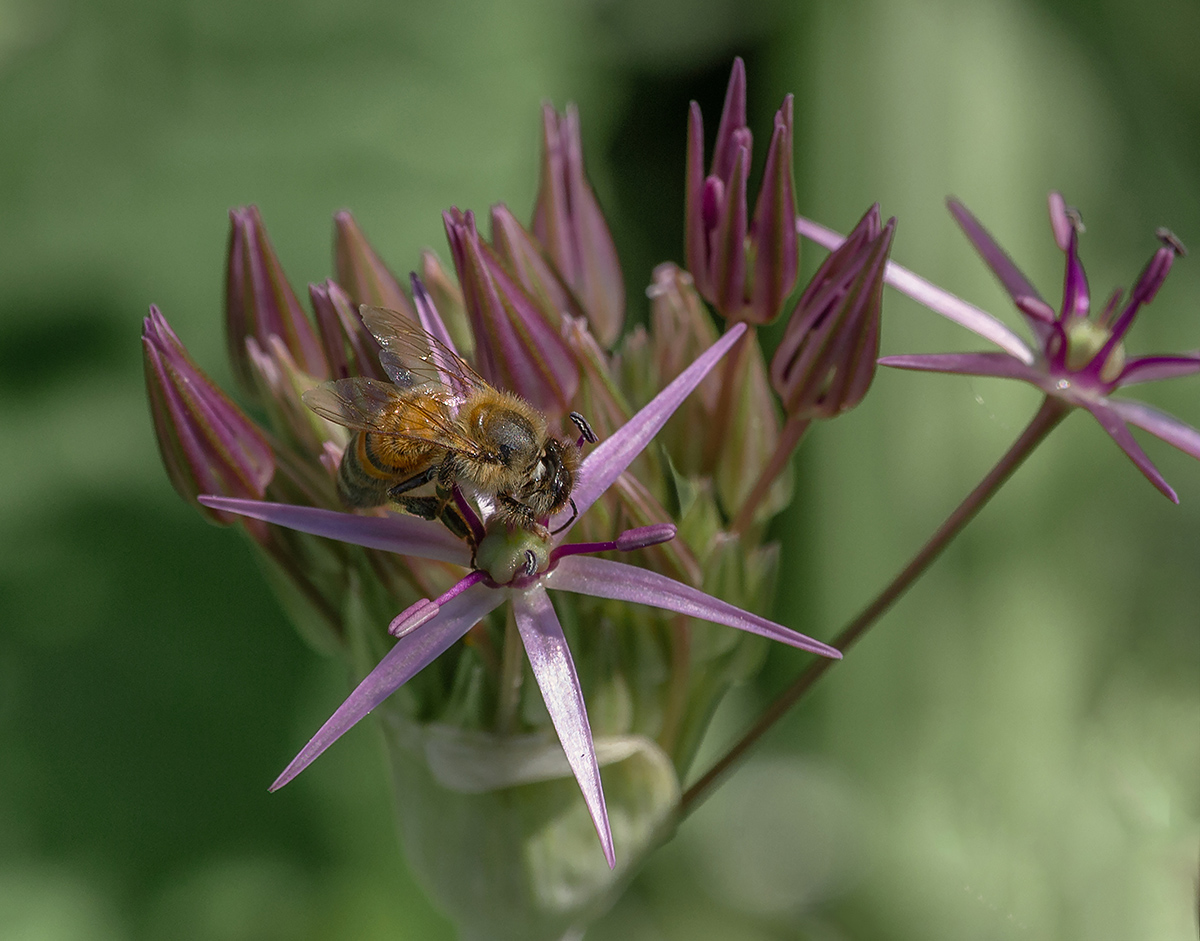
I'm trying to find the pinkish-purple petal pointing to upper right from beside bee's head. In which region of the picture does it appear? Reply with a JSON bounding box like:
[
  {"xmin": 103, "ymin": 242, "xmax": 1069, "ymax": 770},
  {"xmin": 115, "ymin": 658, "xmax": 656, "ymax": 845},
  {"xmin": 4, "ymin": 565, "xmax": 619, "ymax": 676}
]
[{"xmin": 566, "ymin": 324, "xmax": 746, "ymax": 528}]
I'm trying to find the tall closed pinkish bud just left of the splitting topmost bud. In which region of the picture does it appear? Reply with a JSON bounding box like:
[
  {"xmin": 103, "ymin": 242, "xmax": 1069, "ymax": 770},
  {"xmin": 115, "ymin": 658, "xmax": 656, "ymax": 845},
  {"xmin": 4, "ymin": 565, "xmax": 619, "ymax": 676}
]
[{"xmin": 535, "ymin": 104, "xmax": 625, "ymax": 348}]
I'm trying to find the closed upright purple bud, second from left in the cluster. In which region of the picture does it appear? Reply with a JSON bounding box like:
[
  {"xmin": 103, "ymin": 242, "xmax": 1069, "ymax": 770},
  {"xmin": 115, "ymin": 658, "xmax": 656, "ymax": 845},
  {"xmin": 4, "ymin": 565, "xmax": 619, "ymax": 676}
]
[{"xmin": 226, "ymin": 206, "xmax": 329, "ymax": 391}]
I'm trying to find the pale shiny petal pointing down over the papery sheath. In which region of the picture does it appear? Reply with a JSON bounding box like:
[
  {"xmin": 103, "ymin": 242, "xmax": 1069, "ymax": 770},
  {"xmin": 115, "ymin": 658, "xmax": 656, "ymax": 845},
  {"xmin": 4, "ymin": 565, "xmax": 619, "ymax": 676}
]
[{"xmin": 512, "ymin": 585, "xmax": 617, "ymax": 869}]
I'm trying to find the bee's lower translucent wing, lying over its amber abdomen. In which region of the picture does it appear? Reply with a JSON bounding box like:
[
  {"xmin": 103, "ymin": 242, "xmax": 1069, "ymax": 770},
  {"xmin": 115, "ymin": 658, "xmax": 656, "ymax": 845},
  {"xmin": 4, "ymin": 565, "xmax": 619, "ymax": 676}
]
[{"xmin": 301, "ymin": 376, "xmax": 486, "ymax": 460}]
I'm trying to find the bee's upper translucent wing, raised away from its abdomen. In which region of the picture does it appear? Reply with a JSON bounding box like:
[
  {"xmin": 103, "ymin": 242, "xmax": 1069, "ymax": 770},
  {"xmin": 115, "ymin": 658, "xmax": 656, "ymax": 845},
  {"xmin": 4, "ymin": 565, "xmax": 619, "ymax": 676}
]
[{"xmin": 360, "ymin": 305, "xmax": 492, "ymax": 397}]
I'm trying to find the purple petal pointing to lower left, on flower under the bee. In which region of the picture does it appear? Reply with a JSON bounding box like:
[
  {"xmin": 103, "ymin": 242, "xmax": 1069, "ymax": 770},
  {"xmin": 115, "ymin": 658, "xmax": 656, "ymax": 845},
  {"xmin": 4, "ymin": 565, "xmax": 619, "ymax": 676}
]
[{"xmin": 270, "ymin": 585, "xmax": 505, "ymax": 791}]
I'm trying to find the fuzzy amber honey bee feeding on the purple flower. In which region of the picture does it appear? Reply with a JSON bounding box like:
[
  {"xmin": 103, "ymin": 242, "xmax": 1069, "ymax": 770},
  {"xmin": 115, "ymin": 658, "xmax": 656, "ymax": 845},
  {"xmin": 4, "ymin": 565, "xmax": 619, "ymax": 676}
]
[{"xmin": 304, "ymin": 306, "xmax": 596, "ymax": 544}]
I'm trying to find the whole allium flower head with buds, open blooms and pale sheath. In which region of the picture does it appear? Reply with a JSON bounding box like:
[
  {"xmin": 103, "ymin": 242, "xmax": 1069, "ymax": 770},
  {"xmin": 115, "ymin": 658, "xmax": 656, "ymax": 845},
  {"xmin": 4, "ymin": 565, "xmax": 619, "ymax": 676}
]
[{"xmin": 143, "ymin": 60, "xmax": 1200, "ymax": 939}]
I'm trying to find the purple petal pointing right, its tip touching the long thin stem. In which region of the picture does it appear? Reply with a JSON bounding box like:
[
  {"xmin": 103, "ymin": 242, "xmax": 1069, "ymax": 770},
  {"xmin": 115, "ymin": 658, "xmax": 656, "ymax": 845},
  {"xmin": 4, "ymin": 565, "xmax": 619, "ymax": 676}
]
[{"xmin": 542, "ymin": 556, "xmax": 841, "ymax": 660}]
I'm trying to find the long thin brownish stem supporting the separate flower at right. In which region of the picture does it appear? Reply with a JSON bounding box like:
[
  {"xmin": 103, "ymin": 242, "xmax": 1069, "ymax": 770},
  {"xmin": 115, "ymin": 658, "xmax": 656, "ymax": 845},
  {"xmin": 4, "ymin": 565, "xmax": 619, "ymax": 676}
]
[{"xmin": 679, "ymin": 397, "xmax": 1070, "ymax": 819}]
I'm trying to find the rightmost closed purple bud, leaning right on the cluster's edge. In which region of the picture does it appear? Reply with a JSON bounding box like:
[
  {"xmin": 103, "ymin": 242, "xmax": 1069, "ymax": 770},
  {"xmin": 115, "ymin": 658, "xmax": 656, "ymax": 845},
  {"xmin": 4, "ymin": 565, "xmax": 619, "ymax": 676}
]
[{"xmin": 770, "ymin": 210, "xmax": 895, "ymax": 419}]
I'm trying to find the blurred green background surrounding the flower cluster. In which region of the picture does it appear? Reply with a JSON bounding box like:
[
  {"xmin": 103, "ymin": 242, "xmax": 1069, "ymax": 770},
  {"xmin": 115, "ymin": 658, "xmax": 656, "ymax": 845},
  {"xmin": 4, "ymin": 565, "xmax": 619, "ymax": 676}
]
[{"xmin": 0, "ymin": 0, "xmax": 1200, "ymax": 941}]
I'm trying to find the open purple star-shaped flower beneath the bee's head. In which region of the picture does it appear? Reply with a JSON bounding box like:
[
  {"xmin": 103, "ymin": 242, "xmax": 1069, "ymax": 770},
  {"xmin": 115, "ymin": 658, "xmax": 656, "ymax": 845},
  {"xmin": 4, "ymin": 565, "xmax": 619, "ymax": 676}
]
[{"xmin": 199, "ymin": 314, "xmax": 841, "ymax": 867}]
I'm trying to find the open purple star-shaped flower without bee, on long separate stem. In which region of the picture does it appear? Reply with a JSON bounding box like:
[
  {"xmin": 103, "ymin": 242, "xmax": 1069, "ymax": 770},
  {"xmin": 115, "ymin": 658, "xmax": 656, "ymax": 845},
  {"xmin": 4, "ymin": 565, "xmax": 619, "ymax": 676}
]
[{"xmin": 798, "ymin": 192, "xmax": 1200, "ymax": 503}]
